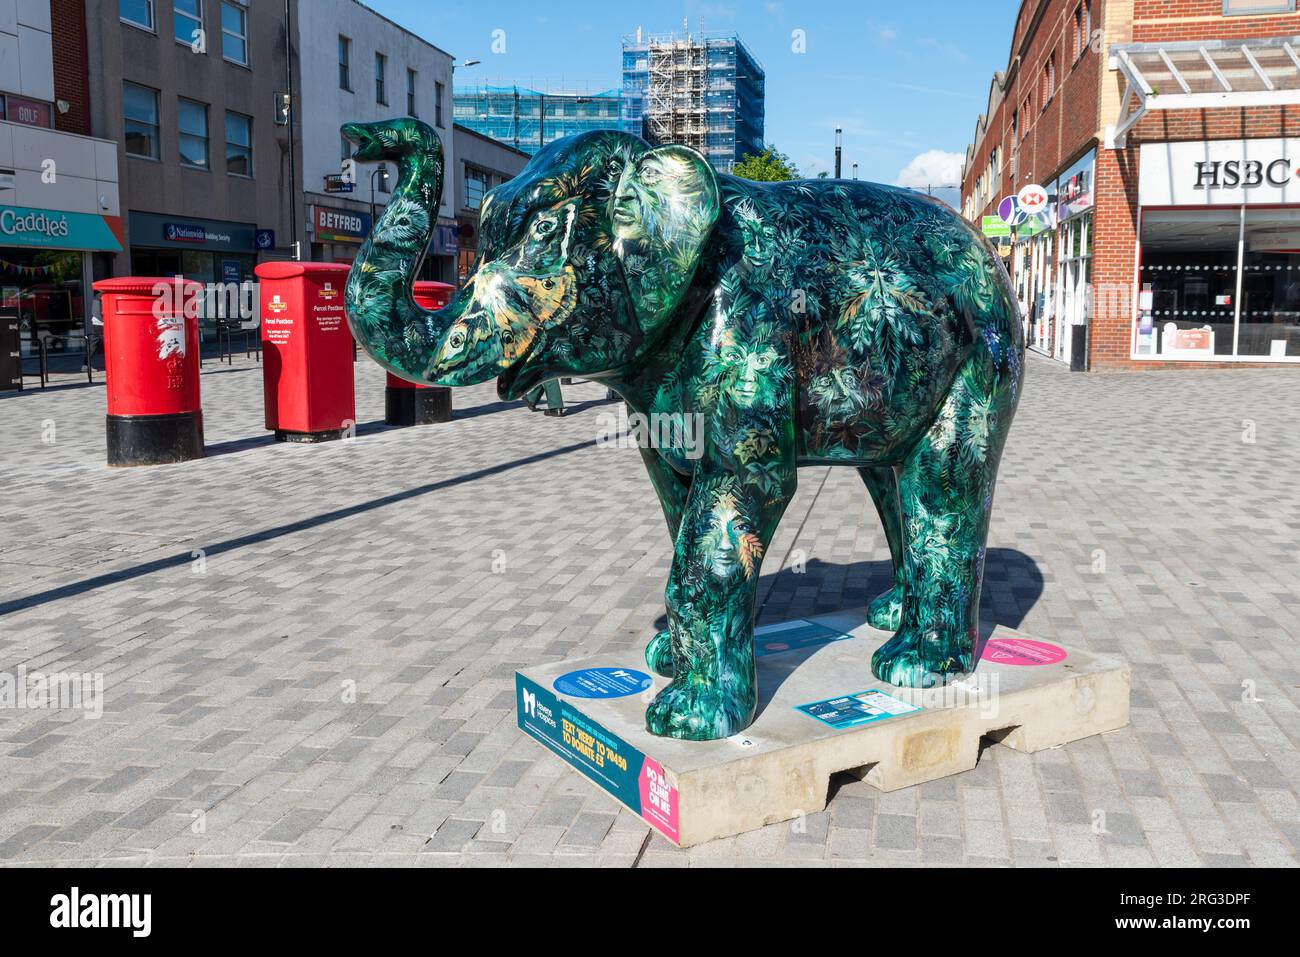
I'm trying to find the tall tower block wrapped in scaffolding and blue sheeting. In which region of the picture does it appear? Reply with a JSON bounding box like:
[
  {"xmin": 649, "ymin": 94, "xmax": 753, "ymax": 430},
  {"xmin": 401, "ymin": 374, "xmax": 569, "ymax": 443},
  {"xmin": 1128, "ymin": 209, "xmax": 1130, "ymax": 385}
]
[{"xmin": 623, "ymin": 29, "xmax": 766, "ymax": 170}]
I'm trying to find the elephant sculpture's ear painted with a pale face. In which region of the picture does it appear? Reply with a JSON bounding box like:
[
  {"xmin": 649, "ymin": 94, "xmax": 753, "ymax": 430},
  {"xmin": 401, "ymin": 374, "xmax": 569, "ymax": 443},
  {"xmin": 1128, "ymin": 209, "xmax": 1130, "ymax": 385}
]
[{"xmin": 610, "ymin": 146, "xmax": 720, "ymax": 332}]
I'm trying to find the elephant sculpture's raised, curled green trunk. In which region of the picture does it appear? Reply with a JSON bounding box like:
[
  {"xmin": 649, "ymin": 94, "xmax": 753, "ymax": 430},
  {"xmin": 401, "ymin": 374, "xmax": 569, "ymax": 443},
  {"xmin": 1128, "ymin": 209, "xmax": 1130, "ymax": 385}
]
[{"xmin": 342, "ymin": 118, "xmax": 467, "ymax": 385}]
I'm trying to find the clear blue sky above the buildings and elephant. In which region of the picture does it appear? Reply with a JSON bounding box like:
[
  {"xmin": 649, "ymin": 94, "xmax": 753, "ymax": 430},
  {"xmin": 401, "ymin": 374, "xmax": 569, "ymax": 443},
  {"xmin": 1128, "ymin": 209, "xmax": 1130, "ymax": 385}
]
[{"xmin": 367, "ymin": 0, "xmax": 1018, "ymax": 198}]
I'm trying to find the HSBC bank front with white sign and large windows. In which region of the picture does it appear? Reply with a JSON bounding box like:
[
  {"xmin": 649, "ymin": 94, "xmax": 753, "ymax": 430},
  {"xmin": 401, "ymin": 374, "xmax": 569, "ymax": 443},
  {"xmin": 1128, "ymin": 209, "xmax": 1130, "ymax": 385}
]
[{"xmin": 1132, "ymin": 138, "xmax": 1300, "ymax": 363}]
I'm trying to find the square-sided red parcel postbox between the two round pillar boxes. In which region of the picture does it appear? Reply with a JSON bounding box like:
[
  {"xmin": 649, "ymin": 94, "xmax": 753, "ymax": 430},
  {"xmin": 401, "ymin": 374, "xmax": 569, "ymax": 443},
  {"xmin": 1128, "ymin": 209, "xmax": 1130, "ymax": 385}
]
[{"xmin": 254, "ymin": 263, "xmax": 356, "ymax": 442}]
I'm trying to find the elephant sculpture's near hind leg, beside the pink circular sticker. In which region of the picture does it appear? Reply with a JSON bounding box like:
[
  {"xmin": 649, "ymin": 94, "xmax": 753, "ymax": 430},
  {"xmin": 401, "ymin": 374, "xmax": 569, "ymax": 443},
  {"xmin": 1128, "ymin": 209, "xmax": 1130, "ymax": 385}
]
[{"xmin": 871, "ymin": 348, "xmax": 1017, "ymax": 688}]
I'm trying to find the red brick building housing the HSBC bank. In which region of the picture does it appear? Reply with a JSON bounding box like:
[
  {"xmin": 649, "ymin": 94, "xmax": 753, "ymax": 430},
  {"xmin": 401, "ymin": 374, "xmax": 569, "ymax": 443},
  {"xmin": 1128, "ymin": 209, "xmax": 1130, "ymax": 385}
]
[{"xmin": 962, "ymin": 0, "xmax": 1300, "ymax": 368}]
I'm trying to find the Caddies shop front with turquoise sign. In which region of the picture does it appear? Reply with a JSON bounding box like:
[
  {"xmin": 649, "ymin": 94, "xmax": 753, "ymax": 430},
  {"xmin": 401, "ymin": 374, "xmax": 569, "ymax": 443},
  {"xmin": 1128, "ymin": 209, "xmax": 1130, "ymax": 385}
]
[{"xmin": 0, "ymin": 205, "xmax": 122, "ymax": 358}]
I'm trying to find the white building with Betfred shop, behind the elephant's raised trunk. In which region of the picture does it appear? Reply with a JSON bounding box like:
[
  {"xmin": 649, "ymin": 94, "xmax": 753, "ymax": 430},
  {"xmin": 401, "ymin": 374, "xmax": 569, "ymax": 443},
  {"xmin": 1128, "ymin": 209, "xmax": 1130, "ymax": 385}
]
[{"xmin": 298, "ymin": 0, "xmax": 458, "ymax": 282}]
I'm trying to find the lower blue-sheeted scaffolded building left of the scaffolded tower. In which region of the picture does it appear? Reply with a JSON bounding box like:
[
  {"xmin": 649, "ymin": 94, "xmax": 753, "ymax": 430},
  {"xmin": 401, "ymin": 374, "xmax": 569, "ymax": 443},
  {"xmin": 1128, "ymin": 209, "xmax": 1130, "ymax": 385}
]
[{"xmin": 452, "ymin": 83, "xmax": 624, "ymax": 153}]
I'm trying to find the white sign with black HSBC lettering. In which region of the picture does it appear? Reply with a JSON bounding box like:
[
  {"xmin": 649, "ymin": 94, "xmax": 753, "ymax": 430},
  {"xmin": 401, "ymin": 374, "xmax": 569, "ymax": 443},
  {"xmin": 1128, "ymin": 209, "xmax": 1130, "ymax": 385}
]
[{"xmin": 1138, "ymin": 138, "xmax": 1300, "ymax": 205}]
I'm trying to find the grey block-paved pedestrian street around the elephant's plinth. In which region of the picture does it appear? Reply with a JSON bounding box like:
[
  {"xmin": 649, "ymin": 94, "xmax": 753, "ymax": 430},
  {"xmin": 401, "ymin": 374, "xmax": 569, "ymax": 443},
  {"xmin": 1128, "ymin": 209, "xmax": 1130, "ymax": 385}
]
[{"xmin": 0, "ymin": 358, "xmax": 1300, "ymax": 867}]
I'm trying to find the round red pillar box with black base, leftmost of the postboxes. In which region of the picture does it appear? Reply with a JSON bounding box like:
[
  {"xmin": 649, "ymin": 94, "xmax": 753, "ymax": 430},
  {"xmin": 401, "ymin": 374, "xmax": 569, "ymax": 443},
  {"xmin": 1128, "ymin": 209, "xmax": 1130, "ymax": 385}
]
[{"xmin": 95, "ymin": 276, "xmax": 203, "ymax": 465}]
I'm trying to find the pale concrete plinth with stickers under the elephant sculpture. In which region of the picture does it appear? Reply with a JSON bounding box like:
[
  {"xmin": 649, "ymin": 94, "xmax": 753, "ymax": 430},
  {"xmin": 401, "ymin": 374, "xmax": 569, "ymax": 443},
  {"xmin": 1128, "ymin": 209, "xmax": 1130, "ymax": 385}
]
[{"xmin": 516, "ymin": 609, "xmax": 1130, "ymax": 846}]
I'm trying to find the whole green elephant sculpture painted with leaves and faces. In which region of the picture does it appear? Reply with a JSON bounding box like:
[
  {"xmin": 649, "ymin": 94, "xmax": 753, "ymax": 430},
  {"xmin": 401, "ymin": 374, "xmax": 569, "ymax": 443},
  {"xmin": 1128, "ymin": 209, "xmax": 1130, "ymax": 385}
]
[{"xmin": 343, "ymin": 118, "xmax": 1024, "ymax": 740}]
